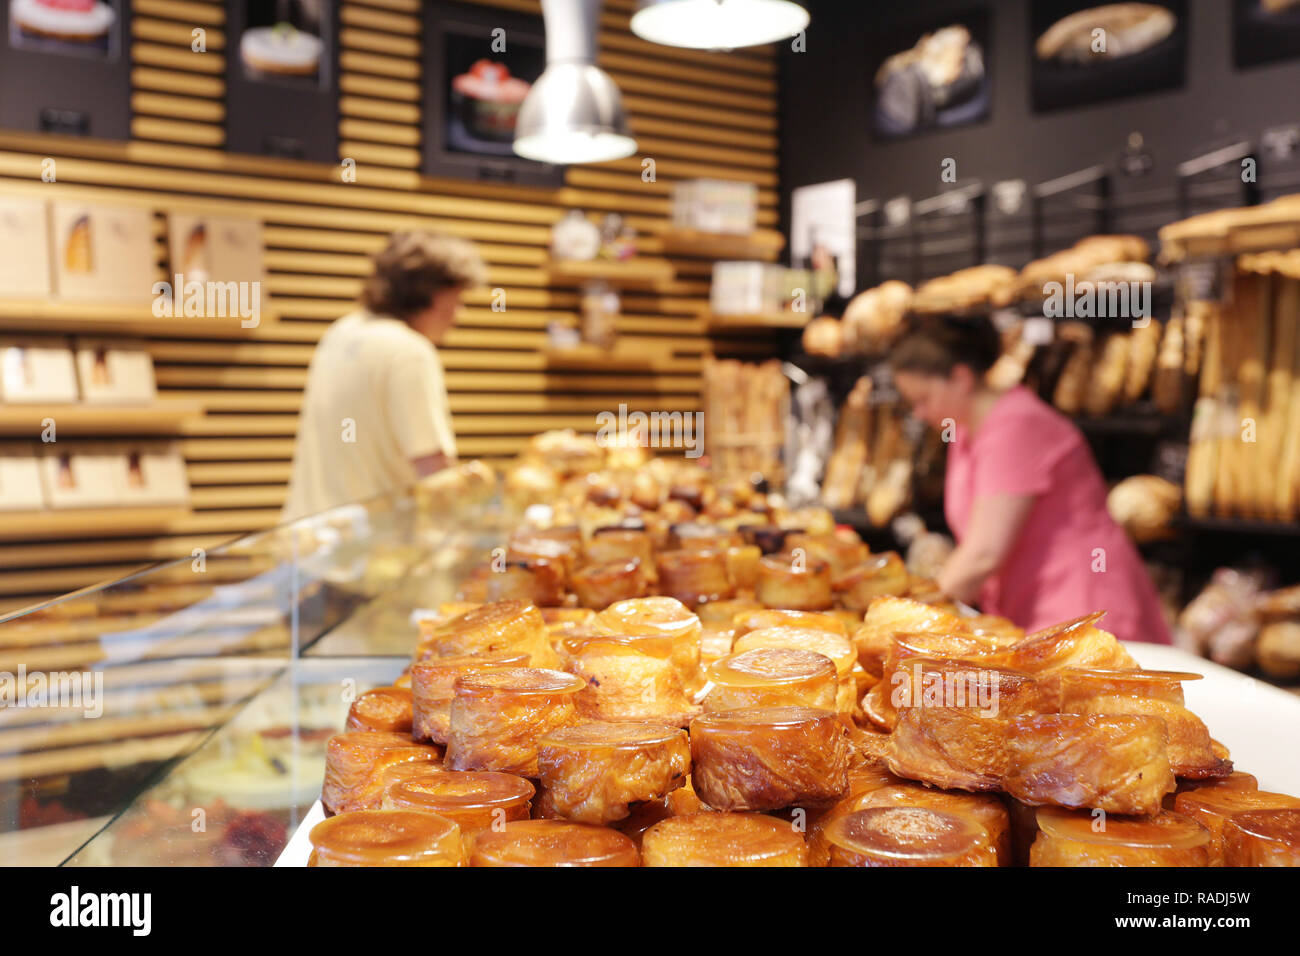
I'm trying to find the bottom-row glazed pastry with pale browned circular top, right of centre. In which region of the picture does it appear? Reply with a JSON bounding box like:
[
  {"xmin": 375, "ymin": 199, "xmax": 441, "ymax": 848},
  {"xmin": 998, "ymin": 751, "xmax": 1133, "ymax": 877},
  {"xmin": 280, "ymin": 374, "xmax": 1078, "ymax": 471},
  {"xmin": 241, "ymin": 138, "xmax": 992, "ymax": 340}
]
[{"xmin": 822, "ymin": 806, "xmax": 997, "ymax": 866}]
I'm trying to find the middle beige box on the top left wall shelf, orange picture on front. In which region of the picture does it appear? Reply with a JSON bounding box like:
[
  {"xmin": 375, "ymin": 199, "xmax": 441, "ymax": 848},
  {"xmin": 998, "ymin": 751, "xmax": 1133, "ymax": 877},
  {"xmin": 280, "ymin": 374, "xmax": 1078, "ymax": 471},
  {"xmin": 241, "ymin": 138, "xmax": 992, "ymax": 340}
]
[{"xmin": 49, "ymin": 202, "xmax": 159, "ymax": 302}]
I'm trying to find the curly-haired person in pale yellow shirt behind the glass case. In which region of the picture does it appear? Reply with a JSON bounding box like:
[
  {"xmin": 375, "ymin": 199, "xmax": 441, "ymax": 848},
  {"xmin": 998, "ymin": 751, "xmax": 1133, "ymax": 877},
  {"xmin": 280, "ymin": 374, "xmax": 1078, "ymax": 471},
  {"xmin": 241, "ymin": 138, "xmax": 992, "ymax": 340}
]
[{"xmin": 282, "ymin": 232, "xmax": 486, "ymax": 520}]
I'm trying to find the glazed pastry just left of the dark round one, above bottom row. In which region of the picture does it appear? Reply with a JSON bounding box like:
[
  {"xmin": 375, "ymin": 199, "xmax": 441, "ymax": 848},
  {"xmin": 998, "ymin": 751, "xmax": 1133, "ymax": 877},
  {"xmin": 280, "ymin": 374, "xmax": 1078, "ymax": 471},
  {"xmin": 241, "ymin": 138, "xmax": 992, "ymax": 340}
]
[{"xmin": 537, "ymin": 722, "xmax": 690, "ymax": 823}]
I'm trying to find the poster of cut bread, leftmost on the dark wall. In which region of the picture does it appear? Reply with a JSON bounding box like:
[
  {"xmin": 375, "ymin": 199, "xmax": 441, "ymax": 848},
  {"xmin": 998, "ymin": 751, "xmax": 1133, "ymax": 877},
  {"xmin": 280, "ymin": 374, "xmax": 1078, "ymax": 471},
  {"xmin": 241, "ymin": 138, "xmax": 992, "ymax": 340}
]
[{"xmin": 867, "ymin": 7, "xmax": 992, "ymax": 139}]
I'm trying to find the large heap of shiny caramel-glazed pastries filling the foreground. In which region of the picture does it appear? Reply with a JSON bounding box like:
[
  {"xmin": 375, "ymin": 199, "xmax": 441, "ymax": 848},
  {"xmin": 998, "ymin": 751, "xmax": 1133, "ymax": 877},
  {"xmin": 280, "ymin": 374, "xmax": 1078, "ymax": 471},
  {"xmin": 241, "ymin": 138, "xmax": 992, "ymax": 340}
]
[{"xmin": 311, "ymin": 468, "xmax": 1300, "ymax": 866}]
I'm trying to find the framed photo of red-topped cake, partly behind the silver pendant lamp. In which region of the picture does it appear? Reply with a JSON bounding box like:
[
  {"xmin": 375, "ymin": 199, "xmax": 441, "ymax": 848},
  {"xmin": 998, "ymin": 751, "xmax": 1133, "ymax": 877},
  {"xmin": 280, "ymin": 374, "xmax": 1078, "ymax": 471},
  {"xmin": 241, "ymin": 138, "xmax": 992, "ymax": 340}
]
[{"xmin": 423, "ymin": 1, "xmax": 564, "ymax": 186}]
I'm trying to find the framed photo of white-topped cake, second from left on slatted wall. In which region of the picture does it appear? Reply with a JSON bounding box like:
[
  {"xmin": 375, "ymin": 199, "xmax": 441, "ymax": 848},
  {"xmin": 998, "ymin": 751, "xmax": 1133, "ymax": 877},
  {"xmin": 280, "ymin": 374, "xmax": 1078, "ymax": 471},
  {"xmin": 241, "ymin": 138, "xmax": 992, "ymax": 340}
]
[{"xmin": 226, "ymin": 0, "xmax": 341, "ymax": 163}]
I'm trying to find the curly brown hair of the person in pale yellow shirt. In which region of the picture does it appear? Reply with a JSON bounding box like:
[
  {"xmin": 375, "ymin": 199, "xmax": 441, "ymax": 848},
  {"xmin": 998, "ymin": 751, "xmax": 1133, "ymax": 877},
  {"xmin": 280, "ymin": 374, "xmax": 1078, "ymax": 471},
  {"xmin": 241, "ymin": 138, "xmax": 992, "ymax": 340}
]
[{"xmin": 361, "ymin": 230, "xmax": 488, "ymax": 321}]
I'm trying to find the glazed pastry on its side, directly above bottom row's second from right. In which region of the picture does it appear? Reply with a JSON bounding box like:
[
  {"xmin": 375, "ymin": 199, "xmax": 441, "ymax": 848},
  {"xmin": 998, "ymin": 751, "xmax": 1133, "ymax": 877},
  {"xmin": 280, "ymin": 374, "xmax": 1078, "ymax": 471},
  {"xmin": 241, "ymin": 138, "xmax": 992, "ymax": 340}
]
[{"xmin": 1002, "ymin": 714, "xmax": 1192, "ymax": 816}]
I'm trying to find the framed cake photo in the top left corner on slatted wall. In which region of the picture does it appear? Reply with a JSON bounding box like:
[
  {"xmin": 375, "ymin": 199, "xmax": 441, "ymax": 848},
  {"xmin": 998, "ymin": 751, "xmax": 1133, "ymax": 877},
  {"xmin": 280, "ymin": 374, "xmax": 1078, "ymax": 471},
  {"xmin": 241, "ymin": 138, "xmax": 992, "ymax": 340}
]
[{"xmin": 0, "ymin": 0, "xmax": 131, "ymax": 139}]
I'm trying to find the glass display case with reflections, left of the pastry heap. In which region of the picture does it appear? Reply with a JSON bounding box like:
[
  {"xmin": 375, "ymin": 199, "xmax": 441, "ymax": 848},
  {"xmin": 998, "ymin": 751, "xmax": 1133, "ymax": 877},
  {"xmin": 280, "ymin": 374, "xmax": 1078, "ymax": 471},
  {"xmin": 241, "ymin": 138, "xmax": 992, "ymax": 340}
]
[{"xmin": 0, "ymin": 472, "xmax": 504, "ymax": 866}]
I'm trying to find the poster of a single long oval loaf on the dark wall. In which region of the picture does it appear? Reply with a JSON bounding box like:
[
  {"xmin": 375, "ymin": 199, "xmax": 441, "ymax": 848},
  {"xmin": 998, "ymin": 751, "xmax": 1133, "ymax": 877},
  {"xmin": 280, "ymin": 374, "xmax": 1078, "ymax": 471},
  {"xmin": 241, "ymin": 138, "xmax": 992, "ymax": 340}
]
[{"xmin": 1030, "ymin": 0, "xmax": 1188, "ymax": 112}]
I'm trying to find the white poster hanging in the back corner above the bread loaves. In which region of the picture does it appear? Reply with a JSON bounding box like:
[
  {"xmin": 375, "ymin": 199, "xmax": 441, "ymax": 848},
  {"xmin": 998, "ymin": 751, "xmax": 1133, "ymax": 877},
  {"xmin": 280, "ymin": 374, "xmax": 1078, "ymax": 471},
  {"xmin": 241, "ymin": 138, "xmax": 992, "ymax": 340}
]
[{"xmin": 790, "ymin": 179, "xmax": 858, "ymax": 298}]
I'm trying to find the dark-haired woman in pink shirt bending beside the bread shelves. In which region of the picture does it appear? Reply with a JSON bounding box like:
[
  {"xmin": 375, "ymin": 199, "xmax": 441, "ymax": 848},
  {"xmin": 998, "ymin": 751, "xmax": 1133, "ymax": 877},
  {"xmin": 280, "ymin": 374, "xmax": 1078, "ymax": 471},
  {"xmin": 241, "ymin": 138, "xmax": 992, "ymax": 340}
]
[{"xmin": 891, "ymin": 316, "xmax": 1170, "ymax": 644}]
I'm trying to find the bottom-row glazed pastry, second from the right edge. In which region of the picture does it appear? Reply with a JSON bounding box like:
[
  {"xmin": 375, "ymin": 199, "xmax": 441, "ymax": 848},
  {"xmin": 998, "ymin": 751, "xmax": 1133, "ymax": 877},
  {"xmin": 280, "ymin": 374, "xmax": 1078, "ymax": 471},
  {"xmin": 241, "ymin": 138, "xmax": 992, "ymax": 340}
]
[{"xmin": 1030, "ymin": 806, "xmax": 1210, "ymax": 866}]
